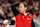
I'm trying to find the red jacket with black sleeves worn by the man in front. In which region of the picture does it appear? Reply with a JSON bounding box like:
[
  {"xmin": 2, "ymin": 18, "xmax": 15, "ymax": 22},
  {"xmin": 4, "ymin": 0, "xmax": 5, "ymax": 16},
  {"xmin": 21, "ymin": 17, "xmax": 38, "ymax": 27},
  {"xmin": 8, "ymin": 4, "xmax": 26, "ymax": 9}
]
[{"xmin": 11, "ymin": 3, "xmax": 35, "ymax": 27}]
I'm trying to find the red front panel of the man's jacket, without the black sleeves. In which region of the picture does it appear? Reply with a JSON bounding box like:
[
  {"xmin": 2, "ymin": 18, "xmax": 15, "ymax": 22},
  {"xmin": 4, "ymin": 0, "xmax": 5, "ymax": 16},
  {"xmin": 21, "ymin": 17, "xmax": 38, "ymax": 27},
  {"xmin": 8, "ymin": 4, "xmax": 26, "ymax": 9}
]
[{"xmin": 16, "ymin": 13, "xmax": 32, "ymax": 27}]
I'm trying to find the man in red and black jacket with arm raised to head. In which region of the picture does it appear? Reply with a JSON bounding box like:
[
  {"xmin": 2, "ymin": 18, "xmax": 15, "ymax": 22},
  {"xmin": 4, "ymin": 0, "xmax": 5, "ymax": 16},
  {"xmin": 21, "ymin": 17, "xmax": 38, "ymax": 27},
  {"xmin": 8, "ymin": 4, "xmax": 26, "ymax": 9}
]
[{"xmin": 11, "ymin": 3, "xmax": 35, "ymax": 27}]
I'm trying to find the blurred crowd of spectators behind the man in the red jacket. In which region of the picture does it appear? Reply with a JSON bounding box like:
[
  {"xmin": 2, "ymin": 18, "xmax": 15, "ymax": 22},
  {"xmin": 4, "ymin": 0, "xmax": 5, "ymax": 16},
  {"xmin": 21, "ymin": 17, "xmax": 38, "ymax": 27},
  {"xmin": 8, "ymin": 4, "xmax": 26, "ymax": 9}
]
[{"xmin": 0, "ymin": 0, "xmax": 40, "ymax": 27}]
